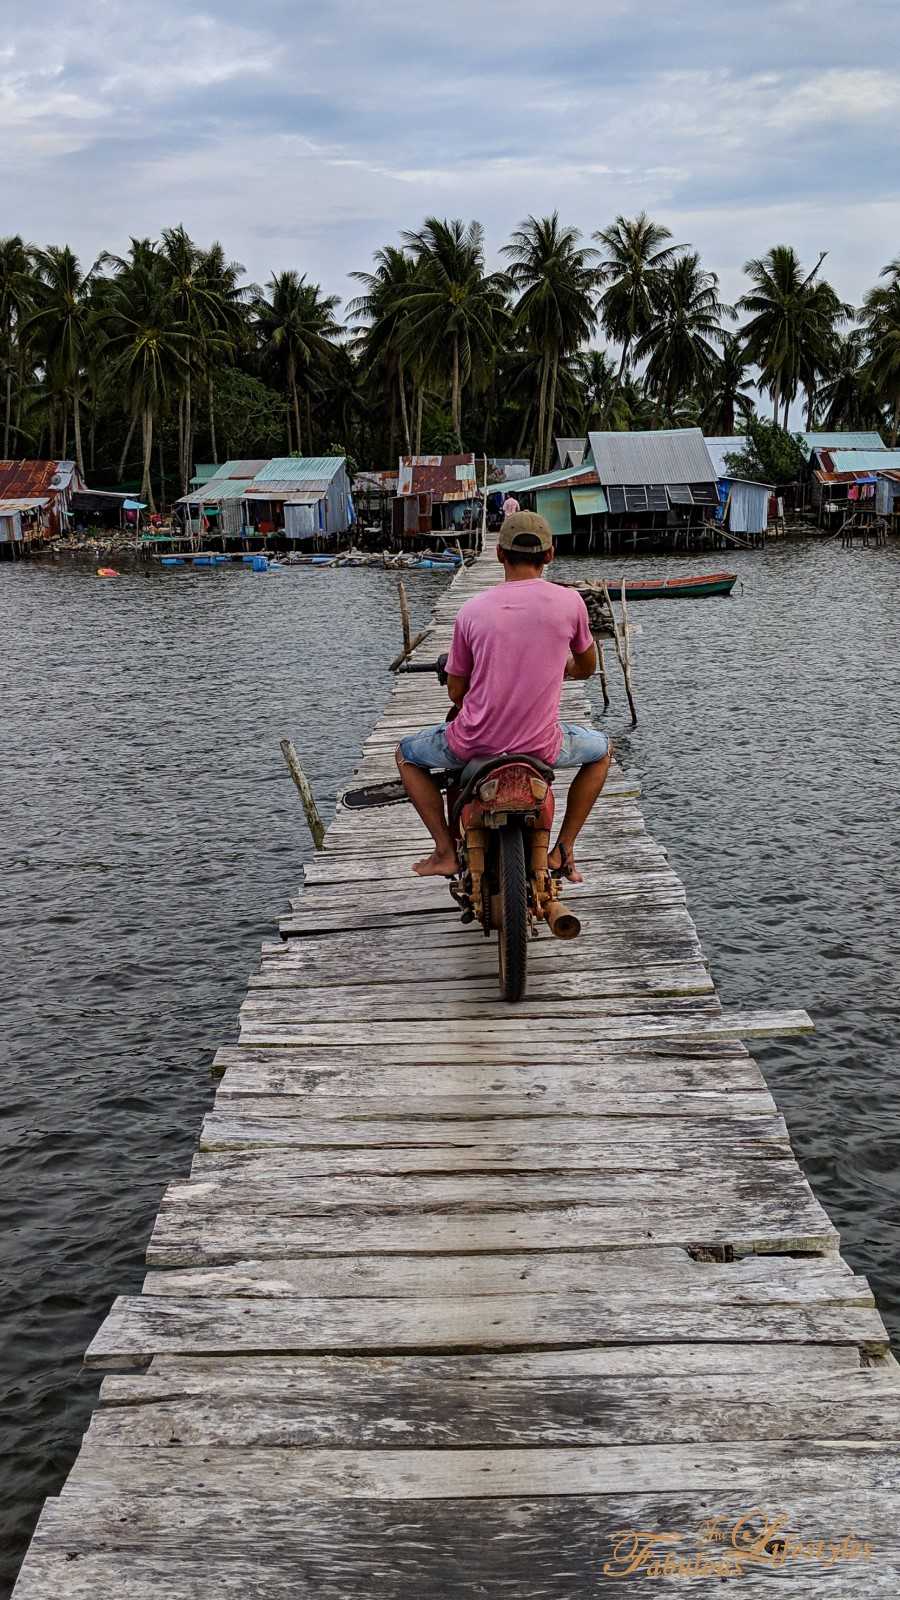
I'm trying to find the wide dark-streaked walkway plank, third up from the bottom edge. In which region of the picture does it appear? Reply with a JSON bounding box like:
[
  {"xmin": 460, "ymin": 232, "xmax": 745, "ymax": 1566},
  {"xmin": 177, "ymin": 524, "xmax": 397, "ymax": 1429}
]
[{"xmin": 86, "ymin": 1374, "xmax": 900, "ymax": 1451}]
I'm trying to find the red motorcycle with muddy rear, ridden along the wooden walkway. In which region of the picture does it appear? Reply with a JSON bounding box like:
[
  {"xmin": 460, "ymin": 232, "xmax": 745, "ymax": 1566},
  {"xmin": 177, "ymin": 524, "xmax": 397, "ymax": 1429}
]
[{"xmin": 343, "ymin": 656, "xmax": 581, "ymax": 1000}]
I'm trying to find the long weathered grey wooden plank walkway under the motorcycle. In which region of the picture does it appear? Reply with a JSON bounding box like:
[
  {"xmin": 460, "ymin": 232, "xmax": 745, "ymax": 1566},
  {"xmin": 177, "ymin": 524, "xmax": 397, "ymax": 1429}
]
[{"xmin": 16, "ymin": 552, "xmax": 900, "ymax": 1600}]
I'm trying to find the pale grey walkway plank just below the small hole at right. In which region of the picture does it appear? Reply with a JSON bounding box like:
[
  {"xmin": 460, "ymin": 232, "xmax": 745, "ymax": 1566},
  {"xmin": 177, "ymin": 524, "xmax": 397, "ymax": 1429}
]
[{"xmin": 144, "ymin": 1246, "xmax": 874, "ymax": 1306}]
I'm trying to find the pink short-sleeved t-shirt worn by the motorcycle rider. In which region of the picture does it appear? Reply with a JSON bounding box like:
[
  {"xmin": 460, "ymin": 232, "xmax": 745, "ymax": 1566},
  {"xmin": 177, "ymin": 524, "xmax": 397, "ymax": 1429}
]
[{"xmin": 447, "ymin": 578, "xmax": 593, "ymax": 763}]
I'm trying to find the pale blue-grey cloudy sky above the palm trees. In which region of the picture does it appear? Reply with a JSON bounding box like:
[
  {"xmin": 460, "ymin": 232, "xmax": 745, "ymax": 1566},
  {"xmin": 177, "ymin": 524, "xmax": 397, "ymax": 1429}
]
[{"xmin": 7, "ymin": 0, "xmax": 900, "ymax": 312}]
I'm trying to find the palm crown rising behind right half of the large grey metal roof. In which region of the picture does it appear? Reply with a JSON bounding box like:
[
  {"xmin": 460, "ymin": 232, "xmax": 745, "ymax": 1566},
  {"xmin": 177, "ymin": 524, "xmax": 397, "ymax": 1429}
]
[{"xmin": 634, "ymin": 251, "xmax": 733, "ymax": 411}]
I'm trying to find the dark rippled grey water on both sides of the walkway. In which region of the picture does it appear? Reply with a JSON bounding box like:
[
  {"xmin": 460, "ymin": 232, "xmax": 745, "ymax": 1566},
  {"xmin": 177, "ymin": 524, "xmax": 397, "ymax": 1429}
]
[{"xmin": 0, "ymin": 544, "xmax": 900, "ymax": 1592}]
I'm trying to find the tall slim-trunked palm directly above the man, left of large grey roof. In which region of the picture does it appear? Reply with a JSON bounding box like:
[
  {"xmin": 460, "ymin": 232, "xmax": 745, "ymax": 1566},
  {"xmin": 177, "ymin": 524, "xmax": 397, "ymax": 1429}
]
[{"xmin": 503, "ymin": 211, "xmax": 599, "ymax": 472}]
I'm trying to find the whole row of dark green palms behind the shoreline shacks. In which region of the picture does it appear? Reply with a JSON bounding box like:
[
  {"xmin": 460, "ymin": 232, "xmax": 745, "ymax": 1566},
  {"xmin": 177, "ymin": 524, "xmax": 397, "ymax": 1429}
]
[{"xmin": 0, "ymin": 213, "xmax": 900, "ymax": 504}]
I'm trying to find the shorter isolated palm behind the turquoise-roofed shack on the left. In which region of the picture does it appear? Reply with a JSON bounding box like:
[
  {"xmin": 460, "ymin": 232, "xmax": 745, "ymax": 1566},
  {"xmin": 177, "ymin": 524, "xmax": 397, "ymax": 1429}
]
[{"xmin": 253, "ymin": 270, "xmax": 340, "ymax": 454}]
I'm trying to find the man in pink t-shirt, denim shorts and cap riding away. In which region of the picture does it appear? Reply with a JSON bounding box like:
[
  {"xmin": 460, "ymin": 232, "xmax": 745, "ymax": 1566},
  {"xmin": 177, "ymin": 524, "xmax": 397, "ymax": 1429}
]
[{"xmin": 397, "ymin": 510, "xmax": 612, "ymax": 883}]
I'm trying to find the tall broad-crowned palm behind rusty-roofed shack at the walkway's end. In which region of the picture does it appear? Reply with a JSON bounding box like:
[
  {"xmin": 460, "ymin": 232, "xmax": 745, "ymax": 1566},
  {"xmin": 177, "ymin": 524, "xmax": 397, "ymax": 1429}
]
[{"xmin": 397, "ymin": 216, "xmax": 508, "ymax": 446}]
